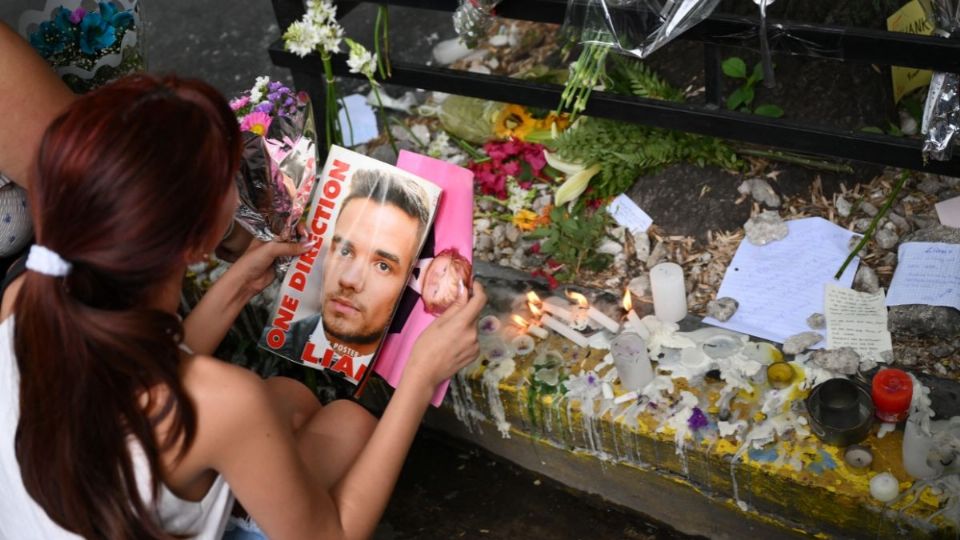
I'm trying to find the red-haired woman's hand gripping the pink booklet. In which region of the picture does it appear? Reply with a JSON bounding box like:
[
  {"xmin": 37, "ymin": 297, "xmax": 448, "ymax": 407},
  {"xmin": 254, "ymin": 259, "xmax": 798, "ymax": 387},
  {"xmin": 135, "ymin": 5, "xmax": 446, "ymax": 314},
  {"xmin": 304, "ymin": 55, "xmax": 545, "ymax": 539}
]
[{"xmin": 403, "ymin": 282, "xmax": 487, "ymax": 391}]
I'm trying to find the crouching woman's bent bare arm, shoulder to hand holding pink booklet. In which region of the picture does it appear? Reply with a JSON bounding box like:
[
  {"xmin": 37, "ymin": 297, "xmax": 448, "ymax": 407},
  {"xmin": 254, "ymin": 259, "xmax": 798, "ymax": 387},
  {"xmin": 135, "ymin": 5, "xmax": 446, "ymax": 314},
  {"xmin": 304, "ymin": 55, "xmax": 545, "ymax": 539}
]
[{"xmin": 191, "ymin": 286, "xmax": 485, "ymax": 540}]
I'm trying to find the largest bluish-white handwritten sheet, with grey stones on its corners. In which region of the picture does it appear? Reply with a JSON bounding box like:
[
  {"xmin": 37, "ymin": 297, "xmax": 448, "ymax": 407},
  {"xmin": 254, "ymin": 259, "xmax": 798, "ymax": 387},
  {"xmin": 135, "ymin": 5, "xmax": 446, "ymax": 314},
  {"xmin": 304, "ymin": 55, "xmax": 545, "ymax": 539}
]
[{"xmin": 703, "ymin": 217, "xmax": 859, "ymax": 343}]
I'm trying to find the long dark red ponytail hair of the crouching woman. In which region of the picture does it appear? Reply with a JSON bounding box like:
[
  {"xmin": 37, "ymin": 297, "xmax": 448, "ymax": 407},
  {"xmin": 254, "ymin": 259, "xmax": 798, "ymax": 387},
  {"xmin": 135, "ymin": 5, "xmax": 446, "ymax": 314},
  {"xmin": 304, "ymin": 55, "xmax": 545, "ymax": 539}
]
[{"xmin": 14, "ymin": 75, "xmax": 240, "ymax": 539}]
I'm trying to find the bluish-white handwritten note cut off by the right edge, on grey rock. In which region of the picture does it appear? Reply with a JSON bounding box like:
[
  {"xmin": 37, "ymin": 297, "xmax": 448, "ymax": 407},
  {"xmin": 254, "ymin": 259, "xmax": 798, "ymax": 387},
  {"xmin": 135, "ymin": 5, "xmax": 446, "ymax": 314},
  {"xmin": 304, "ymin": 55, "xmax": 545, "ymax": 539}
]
[{"xmin": 887, "ymin": 242, "xmax": 960, "ymax": 309}]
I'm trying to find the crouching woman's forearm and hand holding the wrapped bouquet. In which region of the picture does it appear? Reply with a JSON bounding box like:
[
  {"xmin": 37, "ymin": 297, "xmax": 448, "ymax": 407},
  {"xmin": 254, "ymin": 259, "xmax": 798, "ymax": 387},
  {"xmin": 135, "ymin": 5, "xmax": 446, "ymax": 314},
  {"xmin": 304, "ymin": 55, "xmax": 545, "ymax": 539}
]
[{"xmin": 183, "ymin": 242, "xmax": 309, "ymax": 355}]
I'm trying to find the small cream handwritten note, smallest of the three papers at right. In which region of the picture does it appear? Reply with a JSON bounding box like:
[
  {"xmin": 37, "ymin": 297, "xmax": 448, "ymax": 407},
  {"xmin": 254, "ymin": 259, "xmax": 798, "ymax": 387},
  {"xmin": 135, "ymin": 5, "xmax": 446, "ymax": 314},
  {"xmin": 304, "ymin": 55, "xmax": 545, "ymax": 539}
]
[{"xmin": 823, "ymin": 284, "xmax": 893, "ymax": 362}]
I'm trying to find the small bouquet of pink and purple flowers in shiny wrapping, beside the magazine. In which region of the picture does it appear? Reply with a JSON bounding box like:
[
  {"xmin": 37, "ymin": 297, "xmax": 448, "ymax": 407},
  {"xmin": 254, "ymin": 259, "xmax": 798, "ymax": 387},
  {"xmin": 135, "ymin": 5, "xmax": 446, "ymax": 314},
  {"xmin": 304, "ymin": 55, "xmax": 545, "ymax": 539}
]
[{"xmin": 230, "ymin": 77, "xmax": 317, "ymax": 245}]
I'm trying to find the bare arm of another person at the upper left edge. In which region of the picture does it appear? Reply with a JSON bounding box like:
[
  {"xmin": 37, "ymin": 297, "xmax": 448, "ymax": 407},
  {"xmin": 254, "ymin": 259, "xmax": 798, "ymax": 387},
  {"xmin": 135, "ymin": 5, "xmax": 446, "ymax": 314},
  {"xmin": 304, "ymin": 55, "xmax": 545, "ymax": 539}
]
[{"xmin": 0, "ymin": 23, "xmax": 75, "ymax": 188}]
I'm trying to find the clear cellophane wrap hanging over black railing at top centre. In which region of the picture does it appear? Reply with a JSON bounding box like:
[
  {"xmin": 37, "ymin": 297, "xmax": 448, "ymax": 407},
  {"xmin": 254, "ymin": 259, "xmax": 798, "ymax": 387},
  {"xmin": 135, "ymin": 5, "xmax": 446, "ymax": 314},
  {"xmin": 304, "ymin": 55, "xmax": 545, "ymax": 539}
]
[{"xmin": 564, "ymin": 0, "xmax": 720, "ymax": 58}]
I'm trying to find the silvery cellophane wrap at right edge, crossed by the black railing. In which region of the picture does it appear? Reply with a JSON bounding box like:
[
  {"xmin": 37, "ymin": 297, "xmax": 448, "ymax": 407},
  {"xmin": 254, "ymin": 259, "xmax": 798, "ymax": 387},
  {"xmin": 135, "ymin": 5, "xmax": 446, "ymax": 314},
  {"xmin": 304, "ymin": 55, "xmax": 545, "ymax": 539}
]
[{"xmin": 920, "ymin": 0, "xmax": 960, "ymax": 161}]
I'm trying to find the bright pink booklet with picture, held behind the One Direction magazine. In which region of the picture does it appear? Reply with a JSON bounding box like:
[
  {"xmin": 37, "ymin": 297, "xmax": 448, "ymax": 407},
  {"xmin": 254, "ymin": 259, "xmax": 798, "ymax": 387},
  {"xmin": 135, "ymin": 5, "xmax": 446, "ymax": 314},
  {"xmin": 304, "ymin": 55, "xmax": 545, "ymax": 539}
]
[{"xmin": 374, "ymin": 150, "xmax": 473, "ymax": 406}]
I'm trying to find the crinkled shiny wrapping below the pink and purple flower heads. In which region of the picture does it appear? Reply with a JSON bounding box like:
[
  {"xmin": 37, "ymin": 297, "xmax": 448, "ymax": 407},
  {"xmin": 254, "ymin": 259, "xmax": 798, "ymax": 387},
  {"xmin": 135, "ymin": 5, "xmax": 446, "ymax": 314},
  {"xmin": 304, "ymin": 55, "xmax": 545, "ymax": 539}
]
[{"xmin": 235, "ymin": 94, "xmax": 317, "ymax": 242}]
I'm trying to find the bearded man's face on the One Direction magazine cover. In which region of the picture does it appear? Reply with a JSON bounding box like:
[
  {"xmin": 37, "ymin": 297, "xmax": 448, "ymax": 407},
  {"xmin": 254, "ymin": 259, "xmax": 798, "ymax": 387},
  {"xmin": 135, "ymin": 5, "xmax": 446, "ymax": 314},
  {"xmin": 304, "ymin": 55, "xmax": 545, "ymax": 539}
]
[{"xmin": 322, "ymin": 198, "xmax": 419, "ymax": 346}]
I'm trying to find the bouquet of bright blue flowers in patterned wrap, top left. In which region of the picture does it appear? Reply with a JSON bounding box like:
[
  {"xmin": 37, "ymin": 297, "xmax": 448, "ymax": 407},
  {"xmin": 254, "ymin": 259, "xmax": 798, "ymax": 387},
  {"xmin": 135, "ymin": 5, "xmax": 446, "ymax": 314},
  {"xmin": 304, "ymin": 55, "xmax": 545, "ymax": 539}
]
[{"xmin": 19, "ymin": 0, "xmax": 144, "ymax": 93}]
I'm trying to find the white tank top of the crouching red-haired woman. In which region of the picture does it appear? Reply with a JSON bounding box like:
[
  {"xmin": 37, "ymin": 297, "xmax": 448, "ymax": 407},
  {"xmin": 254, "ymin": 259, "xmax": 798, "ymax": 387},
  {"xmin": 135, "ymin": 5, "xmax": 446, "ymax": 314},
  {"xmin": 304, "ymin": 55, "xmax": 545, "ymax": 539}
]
[{"xmin": 0, "ymin": 316, "xmax": 233, "ymax": 540}]
